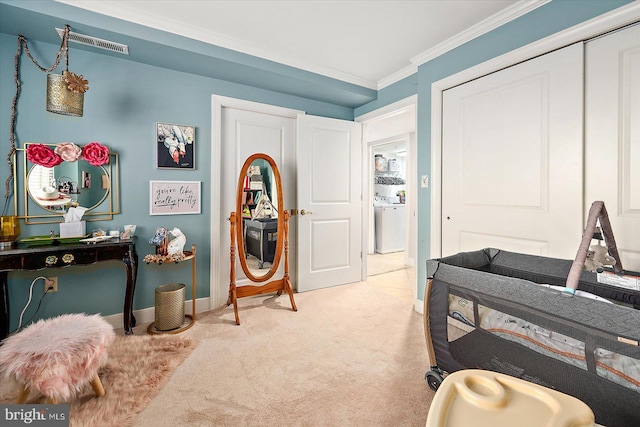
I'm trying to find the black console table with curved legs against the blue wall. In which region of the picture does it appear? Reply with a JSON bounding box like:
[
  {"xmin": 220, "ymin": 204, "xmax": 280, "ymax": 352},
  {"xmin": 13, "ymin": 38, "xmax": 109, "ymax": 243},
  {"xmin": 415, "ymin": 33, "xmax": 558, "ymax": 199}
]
[{"xmin": 0, "ymin": 240, "xmax": 138, "ymax": 339}]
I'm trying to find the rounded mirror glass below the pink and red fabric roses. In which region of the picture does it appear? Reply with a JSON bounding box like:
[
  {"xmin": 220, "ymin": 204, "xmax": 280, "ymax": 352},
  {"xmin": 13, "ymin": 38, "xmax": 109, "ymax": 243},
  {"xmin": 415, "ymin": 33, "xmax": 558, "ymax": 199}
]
[{"xmin": 27, "ymin": 160, "xmax": 111, "ymax": 214}]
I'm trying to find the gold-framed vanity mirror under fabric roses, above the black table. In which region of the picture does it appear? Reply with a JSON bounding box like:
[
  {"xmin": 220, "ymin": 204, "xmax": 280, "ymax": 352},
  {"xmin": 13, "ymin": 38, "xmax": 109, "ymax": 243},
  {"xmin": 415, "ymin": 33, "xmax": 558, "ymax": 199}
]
[{"xmin": 13, "ymin": 143, "xmax": 120, "ymax": 224}]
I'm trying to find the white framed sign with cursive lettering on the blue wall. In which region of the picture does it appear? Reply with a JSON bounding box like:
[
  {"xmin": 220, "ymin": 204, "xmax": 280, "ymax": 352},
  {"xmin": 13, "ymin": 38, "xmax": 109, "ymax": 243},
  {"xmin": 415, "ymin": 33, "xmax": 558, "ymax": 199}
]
[{"xmin": 149, "ymin": 181, "xmax": 201, "ymax": 215}]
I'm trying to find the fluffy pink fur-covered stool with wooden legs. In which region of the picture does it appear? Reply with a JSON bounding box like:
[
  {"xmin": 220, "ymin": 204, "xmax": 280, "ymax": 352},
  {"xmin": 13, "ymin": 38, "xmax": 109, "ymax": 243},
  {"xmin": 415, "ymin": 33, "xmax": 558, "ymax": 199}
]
[{"xmin": 0, "ymin": 314, "xmax": 115, "ymax": 403}]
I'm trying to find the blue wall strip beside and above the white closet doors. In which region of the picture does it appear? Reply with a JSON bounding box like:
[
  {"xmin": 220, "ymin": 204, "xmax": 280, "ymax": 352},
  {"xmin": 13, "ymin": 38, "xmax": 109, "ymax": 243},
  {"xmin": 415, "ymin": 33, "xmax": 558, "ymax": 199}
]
[{"xmin": 355, "ymin": 0, "xmax": 632, "ymax": 299}]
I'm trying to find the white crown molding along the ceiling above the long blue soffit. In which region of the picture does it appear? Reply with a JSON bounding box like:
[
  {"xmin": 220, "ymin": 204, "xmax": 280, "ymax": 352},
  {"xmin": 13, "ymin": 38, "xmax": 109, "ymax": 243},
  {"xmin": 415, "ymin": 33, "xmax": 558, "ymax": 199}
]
[{"xmin": 55, "ymin": 0, "xmax": 378, "ymax": 89}]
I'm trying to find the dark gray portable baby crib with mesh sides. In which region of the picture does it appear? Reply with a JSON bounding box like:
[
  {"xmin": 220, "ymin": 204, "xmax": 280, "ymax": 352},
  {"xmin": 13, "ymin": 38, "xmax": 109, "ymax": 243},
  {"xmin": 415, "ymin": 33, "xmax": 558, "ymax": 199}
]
[{"xmin": 424, "ymin": 202, "xmax": 640, "ymax": 426}]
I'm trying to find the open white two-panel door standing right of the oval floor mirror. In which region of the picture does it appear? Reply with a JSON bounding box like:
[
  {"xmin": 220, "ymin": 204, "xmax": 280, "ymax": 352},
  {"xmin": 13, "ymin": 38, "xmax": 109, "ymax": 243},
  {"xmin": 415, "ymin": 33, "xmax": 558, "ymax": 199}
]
[{"xmin": 297, "ymin": 114, "xmax": 362, "ymax": 292}]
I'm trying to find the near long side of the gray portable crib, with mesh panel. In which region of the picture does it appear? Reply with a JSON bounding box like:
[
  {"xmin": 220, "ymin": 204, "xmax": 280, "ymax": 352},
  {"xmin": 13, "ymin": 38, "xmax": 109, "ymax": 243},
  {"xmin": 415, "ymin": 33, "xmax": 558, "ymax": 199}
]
[{"xmin": 425, "ymin": 251, "xmax": 640, "ymax": 426}]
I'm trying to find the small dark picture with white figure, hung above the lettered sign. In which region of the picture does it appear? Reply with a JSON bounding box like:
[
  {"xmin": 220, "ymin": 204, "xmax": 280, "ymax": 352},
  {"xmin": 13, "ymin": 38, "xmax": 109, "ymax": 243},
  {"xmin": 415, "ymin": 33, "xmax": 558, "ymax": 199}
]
[{"xmin": 156, "ymin": 122, "xmax": 196, "ymax": 169}]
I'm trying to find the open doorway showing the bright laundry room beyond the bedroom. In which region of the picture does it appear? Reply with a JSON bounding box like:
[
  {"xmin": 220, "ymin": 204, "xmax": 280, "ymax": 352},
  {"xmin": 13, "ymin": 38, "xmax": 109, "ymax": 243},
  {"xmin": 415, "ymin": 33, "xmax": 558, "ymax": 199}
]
[{"xmin": 356, "ymin": 96, "xmax": 417, "ymax": 305}]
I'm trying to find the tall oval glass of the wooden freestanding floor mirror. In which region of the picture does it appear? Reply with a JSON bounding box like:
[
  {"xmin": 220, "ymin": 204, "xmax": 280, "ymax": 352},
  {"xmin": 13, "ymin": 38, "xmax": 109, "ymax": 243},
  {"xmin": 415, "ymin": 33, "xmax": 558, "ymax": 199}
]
[{"xmin": 240, "ymin": 159, "xmax": 279, "ymax": 277}]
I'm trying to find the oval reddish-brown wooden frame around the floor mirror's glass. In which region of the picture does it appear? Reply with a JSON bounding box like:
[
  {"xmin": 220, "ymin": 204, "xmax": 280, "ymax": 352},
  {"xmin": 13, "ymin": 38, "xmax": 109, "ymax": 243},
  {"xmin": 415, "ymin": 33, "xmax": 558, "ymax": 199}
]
[{"xmin": 236, "ymin": 153, "xmax": 284, "ymax": 283}]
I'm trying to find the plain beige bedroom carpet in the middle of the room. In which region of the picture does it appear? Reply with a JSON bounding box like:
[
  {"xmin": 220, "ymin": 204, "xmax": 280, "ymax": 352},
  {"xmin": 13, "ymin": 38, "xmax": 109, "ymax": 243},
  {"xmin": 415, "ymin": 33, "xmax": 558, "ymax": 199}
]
[{"xmin": 136, "ymin": 283, "xmax": 433, "ymax": 426}]
